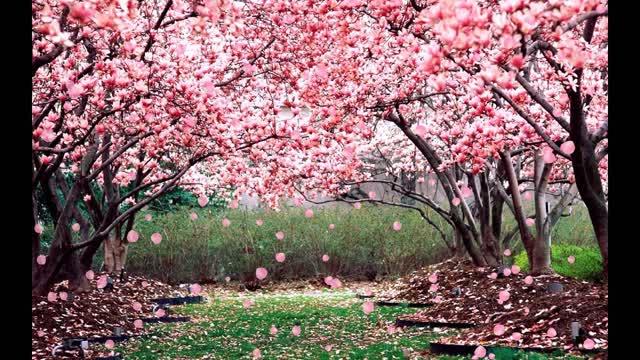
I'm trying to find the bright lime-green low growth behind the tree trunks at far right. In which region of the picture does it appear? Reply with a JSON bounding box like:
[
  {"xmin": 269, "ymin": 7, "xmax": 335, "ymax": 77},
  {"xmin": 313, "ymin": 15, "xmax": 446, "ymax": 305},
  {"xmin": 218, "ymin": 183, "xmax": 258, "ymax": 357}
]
[{"xmin": 515, "ymin": 244, "xmax": 602, "ymax": 281}]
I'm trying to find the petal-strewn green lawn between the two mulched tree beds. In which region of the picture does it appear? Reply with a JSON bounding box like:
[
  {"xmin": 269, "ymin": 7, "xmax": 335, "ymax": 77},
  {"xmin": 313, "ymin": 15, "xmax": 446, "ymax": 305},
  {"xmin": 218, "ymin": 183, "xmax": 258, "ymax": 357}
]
[{"xmin": 116, "ymin": 292, "xmax": 588, "ymax": 360}]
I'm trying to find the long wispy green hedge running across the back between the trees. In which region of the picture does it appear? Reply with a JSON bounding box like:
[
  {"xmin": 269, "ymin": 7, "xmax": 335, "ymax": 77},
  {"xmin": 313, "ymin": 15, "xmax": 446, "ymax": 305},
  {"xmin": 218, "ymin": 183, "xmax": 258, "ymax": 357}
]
[{"xmin": 126, "ymin": 205, "xmax": 447, "ymax": 282}]
